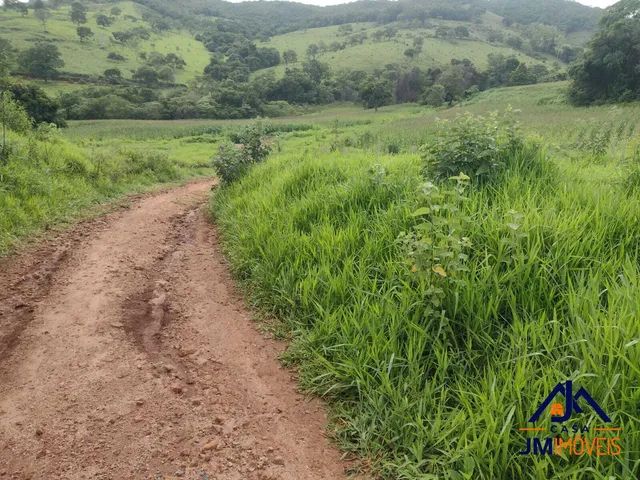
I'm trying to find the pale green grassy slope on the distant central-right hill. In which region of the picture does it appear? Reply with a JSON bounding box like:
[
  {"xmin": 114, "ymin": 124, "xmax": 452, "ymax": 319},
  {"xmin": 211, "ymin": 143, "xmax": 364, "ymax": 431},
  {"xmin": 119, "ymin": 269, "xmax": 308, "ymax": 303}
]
[{"xmin": 261, "ymin": 14, "xmax": 556, "ymax": 75}]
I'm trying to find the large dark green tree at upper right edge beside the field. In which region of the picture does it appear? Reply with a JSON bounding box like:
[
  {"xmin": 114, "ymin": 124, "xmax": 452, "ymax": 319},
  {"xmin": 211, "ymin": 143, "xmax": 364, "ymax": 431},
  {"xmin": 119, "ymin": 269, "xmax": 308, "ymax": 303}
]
[{"xmin": 569, "ymin": 0, "xmax": 640, "ymax": 105}]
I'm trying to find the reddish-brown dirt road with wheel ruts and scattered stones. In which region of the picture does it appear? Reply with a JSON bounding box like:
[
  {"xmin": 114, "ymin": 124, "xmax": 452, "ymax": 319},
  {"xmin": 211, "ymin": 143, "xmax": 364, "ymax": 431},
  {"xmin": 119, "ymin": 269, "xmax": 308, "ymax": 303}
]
[{"xmin": 0, "ymin": 182, "xmax": 345, "ymax": 480}]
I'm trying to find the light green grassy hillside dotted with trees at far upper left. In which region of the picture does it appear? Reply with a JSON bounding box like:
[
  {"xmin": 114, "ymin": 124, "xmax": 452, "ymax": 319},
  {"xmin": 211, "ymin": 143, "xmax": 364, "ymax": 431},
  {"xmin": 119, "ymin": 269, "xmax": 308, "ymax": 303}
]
[{"xmin": 0, "ymin": 2, "xmax": 209, "ymax": 83}]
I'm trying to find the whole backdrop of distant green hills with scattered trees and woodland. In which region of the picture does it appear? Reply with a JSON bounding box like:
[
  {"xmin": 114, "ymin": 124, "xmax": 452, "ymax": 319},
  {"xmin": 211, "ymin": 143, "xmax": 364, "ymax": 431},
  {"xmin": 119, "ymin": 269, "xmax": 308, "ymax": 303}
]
[{"xmin": 0, "ymin": 0, "xmax": 601, "ymax": 119}]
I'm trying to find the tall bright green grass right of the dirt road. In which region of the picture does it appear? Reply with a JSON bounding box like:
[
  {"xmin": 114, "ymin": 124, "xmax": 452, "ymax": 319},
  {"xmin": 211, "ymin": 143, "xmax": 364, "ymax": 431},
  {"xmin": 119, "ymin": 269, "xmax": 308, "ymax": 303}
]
[{"xmin": 211, "ymin": 134, "xmax": 640, "ymax": 480}]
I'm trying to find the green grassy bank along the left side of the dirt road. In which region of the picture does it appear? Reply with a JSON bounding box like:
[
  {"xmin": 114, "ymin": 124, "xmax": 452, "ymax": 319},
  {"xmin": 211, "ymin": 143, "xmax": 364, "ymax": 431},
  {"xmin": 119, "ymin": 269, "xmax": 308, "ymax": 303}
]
[{"xmin": 0, "ymin": 128, "xmax": 213, "ymax": 255}]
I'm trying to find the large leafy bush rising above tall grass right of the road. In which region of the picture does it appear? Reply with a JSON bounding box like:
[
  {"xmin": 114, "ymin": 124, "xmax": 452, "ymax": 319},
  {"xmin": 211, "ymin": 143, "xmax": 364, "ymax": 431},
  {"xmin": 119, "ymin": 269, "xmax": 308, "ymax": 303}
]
[{"xmin": 421, "ymin": 113, "xmax": 524, "ymax": 183}]
